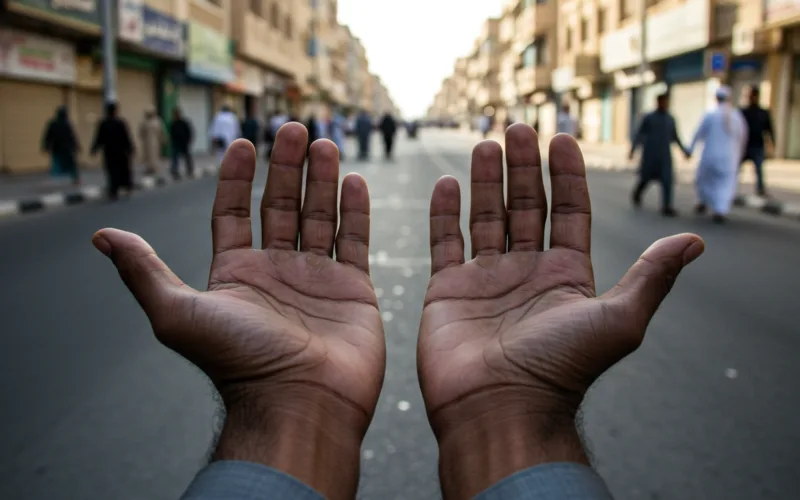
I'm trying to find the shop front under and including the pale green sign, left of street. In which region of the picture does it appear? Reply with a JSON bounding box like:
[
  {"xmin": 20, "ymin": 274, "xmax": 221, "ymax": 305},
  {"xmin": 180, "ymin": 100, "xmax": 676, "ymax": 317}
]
[{"xmin": 177, "ymin": 21, "xmax": 235, "ymax": 153}]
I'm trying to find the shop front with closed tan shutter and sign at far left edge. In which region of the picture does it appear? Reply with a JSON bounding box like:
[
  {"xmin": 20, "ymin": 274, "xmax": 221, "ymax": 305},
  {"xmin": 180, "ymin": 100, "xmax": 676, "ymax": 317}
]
[{"xmin": 0, "ymin": 28, "xmax": 76, "ymax": 173}]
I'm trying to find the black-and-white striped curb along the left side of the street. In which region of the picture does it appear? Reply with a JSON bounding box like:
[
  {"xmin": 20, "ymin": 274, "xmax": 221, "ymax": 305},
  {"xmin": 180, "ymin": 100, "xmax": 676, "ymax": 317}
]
[{"xmin": 0, "ymin": 166, "xmax": 219, "ymax": 218}]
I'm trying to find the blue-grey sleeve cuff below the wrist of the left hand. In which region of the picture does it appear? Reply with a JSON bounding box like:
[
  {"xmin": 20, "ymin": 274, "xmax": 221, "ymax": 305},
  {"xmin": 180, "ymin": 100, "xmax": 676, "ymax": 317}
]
[{"xmin": 181, "ymin": 460, "xmax": 324, "ymax": 500}]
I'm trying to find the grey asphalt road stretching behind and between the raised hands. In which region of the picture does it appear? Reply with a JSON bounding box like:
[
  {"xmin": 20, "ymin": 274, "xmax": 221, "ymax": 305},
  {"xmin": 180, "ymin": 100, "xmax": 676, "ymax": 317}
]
[{"xmin": 0, "ymin": 130, "xmax": 800, "ymax": 500}]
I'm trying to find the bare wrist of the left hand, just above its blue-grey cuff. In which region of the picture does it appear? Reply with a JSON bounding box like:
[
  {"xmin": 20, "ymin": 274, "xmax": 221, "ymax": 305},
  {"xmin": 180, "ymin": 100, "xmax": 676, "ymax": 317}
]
[{"xmin": 213, "ymin": 385, "xmax": 369, "ymax": 499}]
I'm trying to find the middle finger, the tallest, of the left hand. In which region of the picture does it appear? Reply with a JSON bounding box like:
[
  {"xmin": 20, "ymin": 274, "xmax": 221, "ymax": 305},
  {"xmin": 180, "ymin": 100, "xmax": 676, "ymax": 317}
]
[{"xmin": 261, "ymin": 123, "xmax": 308, "ymax": 250}]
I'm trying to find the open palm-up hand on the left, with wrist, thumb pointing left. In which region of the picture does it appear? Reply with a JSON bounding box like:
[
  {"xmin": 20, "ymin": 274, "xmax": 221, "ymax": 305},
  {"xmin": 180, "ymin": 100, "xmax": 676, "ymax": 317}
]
[{"xmin": 93, "ymin": 124, "xmax": 385, "ymax": 499}]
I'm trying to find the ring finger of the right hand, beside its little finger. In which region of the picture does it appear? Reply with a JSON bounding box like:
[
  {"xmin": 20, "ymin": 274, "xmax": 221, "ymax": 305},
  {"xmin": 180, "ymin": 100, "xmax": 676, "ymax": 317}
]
[{"xmin": 469, "ymin": 141, "xmax": 506, "ymax": 258}]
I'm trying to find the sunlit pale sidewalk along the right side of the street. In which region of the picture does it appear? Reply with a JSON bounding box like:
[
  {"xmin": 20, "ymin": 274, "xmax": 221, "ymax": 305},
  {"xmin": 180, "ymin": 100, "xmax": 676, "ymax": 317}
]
[{"xmin": 467, "ymin": 132, "xmax": 800, "ymax": 219}]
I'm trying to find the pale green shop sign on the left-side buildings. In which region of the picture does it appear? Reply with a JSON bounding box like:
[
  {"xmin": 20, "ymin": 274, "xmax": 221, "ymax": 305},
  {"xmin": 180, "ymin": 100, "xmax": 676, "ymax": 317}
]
[{"xmin": 186, "ymin": 21, "xmax": 235, "ymax": 83}]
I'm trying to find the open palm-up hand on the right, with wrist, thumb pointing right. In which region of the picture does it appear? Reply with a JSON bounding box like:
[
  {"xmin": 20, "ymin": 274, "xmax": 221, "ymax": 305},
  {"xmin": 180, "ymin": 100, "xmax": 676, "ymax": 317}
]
[{"xmin": 417, "ymin": 124, "xmax": 703, "ymax": 498}]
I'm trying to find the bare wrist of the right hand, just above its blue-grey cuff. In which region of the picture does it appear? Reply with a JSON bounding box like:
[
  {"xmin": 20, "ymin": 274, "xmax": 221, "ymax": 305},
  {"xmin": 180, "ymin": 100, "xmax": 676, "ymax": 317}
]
[{"xmin": 432, "ymin": 388, "xmax": 589, "ymax": 498}]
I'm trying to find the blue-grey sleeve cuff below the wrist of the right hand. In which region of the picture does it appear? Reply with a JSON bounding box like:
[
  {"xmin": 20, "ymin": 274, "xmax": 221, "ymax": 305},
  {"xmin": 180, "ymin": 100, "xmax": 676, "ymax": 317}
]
[{"xmin": 475, "ymin": 463, "xmax": 613, "ymax": 500}]
